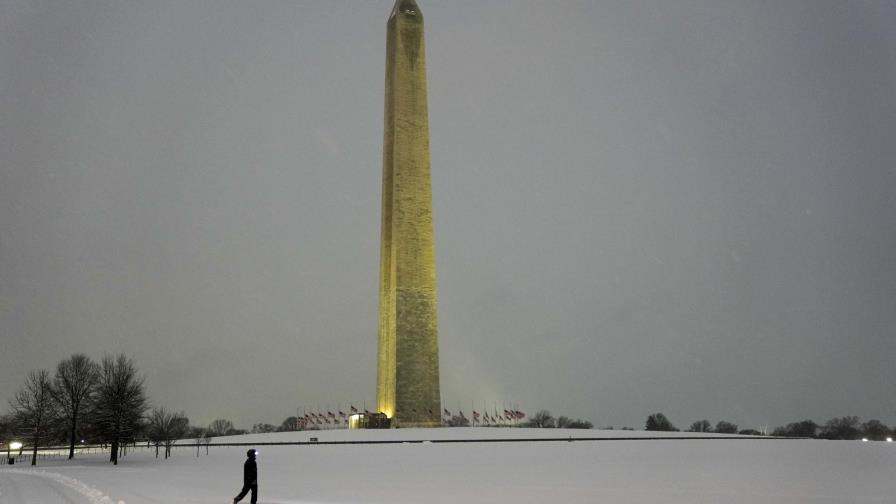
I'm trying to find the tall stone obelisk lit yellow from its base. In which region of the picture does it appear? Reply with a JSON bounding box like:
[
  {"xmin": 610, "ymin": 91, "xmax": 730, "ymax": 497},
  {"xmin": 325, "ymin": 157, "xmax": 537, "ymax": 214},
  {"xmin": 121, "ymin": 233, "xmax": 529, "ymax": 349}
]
[{"xmin": 376, "ymin": 0, "xmax": 442, "ymax": 427}]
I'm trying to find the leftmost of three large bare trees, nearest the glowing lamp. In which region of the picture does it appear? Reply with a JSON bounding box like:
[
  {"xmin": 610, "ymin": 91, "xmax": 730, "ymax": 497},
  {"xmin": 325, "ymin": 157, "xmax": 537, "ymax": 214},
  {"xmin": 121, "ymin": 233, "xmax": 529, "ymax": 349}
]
[{"xmin": 9, "ymin": 369, "xmax": 58, "ymax": 465}]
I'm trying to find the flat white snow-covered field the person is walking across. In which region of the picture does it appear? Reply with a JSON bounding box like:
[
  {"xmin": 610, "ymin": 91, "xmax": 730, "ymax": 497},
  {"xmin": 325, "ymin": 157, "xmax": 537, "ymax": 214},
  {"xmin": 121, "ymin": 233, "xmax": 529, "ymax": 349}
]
[{"xmin": 0, "ymin": 428, "xmax": 896, "ymax": 504}]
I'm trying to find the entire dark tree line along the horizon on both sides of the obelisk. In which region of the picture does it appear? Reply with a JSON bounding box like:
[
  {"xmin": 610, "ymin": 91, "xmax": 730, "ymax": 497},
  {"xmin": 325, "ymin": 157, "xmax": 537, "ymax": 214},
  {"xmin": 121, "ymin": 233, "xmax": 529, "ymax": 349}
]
[{"xmin": 7, "ymin": 354, "xmax": 896, "ymax": 465}]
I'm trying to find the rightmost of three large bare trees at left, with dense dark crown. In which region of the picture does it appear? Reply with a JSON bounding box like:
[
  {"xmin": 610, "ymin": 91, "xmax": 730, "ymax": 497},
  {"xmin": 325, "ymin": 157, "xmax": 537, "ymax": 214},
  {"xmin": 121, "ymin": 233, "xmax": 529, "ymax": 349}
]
[{"xmin": 94, "ymin": 354, "xmax": 146, "ymax": 465}]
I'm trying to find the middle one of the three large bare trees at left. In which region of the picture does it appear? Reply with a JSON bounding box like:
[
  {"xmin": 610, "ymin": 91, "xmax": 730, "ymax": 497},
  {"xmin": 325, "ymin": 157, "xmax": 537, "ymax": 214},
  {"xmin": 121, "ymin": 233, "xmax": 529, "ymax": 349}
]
[{"xmin": 52, "ymin": 354, "xmax": 99, "ymax": 460}]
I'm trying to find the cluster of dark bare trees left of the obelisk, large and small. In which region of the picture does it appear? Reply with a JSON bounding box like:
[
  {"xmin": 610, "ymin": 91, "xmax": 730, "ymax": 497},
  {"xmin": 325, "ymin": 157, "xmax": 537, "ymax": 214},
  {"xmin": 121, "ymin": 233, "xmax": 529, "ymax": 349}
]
[{"xmin": 0, "ymin": 354, "xmax": 280, "ymax": 465}]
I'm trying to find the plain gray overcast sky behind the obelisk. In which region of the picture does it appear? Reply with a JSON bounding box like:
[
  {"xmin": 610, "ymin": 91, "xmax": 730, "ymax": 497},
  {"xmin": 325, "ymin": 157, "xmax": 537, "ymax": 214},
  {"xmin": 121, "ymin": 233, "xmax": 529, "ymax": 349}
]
[{"xmin": 0, "ymin": 0, "xmax": 896, "ymax": 428}]
